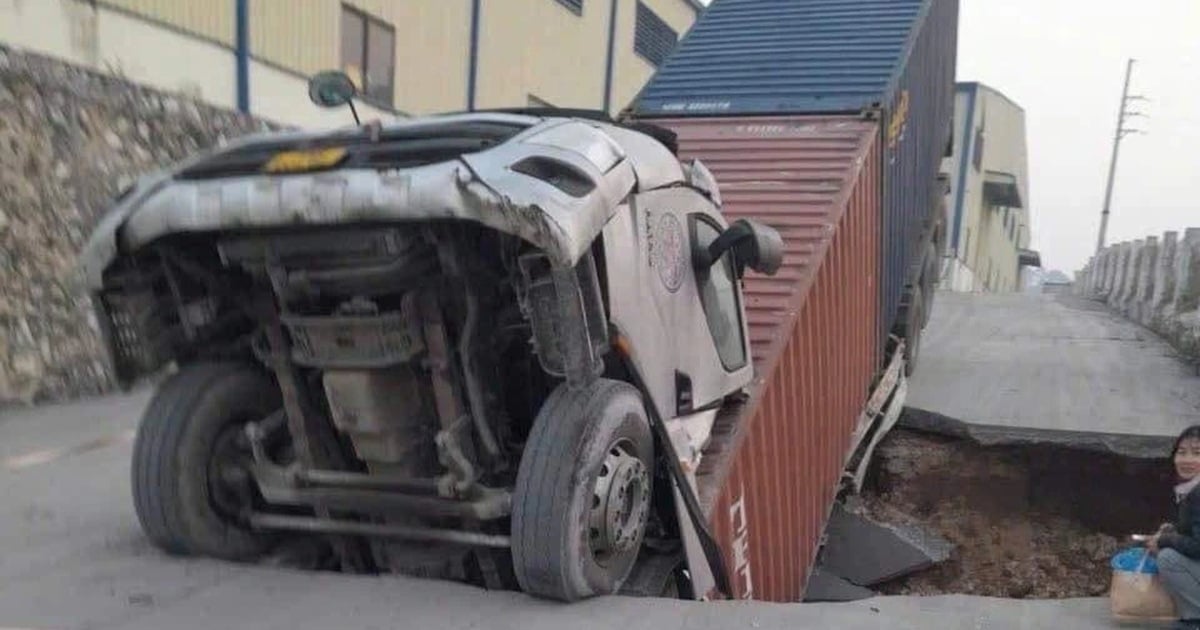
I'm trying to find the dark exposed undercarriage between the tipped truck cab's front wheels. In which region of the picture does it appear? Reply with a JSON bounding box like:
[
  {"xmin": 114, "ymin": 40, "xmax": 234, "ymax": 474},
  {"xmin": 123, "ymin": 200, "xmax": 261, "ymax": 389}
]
[{"xmin": 106, "ymin": 223, "xmax": 686, "ymax": 595}]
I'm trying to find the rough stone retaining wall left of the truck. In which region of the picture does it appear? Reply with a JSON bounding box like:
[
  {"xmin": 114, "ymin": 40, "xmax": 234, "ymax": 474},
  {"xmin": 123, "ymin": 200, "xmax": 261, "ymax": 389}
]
[{"xmin": 0, "ymin": 46, "xmax": 271, "ymax": 404}]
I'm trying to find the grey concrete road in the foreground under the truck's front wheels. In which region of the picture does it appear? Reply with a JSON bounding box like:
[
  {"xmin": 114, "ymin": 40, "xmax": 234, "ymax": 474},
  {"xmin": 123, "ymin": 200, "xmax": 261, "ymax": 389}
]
[{"xmin": 0, "ymin": 386, "xmax": 1142, "ymax": 630}]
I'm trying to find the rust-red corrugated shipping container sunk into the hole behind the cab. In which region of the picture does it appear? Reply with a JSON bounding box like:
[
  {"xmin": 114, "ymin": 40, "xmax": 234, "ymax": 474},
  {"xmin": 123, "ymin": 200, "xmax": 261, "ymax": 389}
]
[{"xmin": 658, "ymin": 118, "xmax": 881, "ymax": 601}]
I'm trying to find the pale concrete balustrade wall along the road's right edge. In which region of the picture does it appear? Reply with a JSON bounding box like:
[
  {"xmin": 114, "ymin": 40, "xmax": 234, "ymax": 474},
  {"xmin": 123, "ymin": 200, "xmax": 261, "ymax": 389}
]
[{"xmin": 1075, "ymin": 228, "xmax": 1200, "ymax": 359}]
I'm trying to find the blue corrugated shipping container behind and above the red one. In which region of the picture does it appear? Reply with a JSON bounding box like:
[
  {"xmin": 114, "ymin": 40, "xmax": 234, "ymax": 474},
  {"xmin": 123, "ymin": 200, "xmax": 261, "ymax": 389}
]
[{"xmin": 631, "ymin": 0, "xmax": 958, "ymax": 362}]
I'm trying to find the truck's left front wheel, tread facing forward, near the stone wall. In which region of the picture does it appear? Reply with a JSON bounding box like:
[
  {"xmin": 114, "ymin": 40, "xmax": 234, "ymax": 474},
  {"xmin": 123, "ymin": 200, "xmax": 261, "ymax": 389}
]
[{"xmin": 132, "ymin": 362, "xmax": 281, "ymax": 560}]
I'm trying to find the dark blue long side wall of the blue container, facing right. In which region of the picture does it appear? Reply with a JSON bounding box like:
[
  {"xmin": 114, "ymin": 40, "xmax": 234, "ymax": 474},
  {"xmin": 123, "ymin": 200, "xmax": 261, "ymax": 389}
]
[{"xmin": 881, "ymin": 0, "xmax": 959, "ymax": 340}]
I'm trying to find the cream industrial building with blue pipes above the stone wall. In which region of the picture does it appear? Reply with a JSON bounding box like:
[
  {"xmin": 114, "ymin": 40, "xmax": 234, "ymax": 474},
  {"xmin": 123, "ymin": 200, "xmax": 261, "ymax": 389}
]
[{"xmin": 0, "ymin": 0, "xmax": 703, "ymax": 127}]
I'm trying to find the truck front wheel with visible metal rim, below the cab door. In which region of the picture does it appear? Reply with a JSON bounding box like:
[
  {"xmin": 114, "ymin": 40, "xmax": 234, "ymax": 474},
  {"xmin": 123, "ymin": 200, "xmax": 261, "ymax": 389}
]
[{"xmin": 512, "ymin": 379, "xmax": 654, "ymax": 601}]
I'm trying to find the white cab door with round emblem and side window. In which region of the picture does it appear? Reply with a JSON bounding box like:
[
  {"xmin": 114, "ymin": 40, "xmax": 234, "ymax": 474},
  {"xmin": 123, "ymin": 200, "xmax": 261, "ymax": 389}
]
[{"xmin": 604, "ymin": 187, "xmax": 752, "ymax": 418}]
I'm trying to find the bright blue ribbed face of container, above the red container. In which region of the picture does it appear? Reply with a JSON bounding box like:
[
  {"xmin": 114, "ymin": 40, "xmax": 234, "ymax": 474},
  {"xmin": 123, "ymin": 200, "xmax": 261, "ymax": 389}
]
[{"xmin": 634, "ymin": 0, "xmax": 931, "ymax": 116}]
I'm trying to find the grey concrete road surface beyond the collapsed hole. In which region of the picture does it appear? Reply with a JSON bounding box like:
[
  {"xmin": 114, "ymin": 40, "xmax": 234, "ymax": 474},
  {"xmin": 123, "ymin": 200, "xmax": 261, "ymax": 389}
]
[{"xmin": 905, "ymin": 293, "xmax": 1200, "ymax": 457}]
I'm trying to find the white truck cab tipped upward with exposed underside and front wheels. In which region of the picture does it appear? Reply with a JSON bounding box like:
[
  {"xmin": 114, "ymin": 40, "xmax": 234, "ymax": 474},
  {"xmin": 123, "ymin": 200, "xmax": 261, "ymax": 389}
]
[{"xmin": 84, "ymin": 94, "xmax": 782, "ymax": 600}]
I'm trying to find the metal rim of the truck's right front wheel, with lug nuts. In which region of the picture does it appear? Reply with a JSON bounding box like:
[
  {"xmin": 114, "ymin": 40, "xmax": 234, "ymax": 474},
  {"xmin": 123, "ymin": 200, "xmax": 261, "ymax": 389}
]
[{"xmin": 588, "ymin": 439, "xmax": 650, "ymax": 565}]
